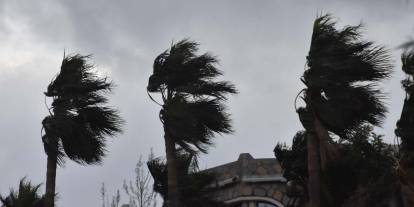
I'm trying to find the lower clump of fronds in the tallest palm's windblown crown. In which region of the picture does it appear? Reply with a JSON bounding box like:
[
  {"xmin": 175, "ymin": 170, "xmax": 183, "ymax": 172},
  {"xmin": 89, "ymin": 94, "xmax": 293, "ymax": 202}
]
[{"xmin": 311, "ymin": 85, "xmax": 387, "ymax": 138}]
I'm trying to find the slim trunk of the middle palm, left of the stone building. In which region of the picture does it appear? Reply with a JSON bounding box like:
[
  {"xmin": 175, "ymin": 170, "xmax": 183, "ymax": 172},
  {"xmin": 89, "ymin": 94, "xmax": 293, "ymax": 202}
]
[{"xmin": 164, "ymin": 127, "xmax": 180, "ymax": 207}]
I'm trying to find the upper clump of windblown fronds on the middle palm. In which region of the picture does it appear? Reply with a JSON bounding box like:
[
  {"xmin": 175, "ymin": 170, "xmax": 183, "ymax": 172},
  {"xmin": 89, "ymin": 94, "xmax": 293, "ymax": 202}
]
[{"xmin": 148, "ymin": 39, "xmax": 236, "ymax": 99}]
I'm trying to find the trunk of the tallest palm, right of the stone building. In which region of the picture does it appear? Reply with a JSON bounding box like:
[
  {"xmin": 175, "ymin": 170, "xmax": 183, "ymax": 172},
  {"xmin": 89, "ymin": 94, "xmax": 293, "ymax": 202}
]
[{"xmin": 306, "ymin": 131, "xmax": 321, "ymax": 207}]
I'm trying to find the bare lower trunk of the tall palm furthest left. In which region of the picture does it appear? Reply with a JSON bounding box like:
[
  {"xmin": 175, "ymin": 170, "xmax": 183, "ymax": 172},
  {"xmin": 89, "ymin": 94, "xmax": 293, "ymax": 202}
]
[{"xmin": 45, "ymin": 156, "xmax": 57, "ymax": 207}]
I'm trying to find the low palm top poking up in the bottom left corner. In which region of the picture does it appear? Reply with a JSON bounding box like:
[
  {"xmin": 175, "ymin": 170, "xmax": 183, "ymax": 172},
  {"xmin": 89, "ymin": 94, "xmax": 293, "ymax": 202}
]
[{"xmin": 0, "ymin": 178, "xmax": 44, "ymax": 207}]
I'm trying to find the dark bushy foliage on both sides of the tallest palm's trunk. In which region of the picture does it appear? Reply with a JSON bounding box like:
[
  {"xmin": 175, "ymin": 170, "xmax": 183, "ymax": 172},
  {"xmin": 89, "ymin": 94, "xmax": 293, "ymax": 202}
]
[{"xmin": 275, "ymin": 125, "xmax": 399, "ymax": 207}]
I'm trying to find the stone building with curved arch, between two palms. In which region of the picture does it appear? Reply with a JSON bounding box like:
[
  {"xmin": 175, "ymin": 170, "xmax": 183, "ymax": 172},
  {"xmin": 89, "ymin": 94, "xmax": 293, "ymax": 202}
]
[{"xmin": 206, "ymin": 153, "xmax": 289, "ymax": 207}]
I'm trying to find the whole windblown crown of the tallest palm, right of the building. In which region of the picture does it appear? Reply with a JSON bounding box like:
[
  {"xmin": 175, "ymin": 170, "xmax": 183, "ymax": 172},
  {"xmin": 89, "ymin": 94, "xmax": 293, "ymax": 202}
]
[{"xmin": 302, "ymin": 15, "xmax": 392, "ymax": 136}]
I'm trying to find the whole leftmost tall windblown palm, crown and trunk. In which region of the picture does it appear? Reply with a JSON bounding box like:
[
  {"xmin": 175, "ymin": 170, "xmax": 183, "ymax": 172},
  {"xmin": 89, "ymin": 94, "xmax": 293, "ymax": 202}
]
[{"xmin": 42, "ymin": 54, "xmax": 122, "ymax": 207}]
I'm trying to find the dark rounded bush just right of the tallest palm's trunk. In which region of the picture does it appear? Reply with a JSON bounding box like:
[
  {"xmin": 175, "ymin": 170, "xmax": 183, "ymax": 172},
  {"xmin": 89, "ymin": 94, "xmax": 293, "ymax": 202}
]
[{"xmin": 326, "ymin": 125, "xmax": 397, "ymax": 207}]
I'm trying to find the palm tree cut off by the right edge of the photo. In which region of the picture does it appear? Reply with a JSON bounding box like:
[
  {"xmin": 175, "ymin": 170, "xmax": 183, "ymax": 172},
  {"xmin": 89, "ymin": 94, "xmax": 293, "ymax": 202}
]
[{"xmin": 395, "ymin": 50, "xmax": 414, "ymax": 207}]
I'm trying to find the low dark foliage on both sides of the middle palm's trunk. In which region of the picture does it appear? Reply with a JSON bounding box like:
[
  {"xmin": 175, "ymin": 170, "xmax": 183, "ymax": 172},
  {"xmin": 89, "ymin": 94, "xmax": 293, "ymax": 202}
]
[{"xmin": 147, "ymin": 151, "xmax": 225, "ymax": 207}]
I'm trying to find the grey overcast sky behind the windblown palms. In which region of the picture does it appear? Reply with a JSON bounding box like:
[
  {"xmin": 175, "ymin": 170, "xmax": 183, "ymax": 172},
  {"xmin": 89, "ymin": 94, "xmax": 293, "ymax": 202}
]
[{"xmin": 0, "ymin": 0, "xmax": 414, "ymax": 207}]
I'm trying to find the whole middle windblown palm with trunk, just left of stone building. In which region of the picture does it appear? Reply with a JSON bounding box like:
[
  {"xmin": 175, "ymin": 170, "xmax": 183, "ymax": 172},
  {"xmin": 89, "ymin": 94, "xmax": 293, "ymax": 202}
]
[{"xmin": 147, "ymin": 39, "xmax": 236, "ymax": 207}]
